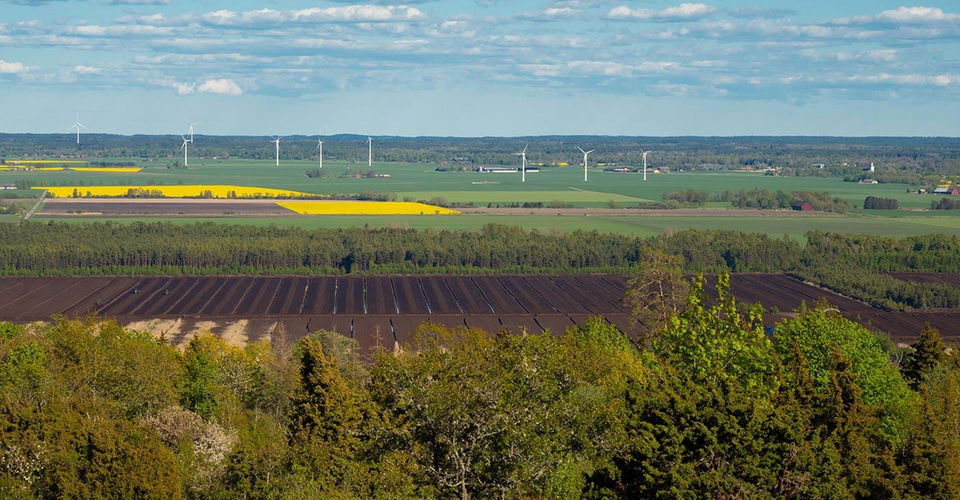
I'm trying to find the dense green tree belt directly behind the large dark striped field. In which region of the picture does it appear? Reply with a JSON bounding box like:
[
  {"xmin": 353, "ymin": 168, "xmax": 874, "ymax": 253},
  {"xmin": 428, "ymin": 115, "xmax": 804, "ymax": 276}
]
[{"xmin": 0, "ymin": 222, "xmax": 960, "ymax": 310}]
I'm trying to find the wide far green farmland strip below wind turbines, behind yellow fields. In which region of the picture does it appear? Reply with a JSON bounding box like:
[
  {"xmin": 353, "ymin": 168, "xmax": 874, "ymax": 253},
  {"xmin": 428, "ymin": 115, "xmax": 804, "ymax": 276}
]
[{"xmin": 0, "ymin": 159, "xmax": 934, "ymax": 208}]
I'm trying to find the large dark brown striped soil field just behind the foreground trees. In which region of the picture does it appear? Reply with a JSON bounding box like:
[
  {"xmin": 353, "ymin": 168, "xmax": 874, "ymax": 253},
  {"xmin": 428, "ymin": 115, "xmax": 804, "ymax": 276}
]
[{"xmin": 0, "ymin": 273, "xmax": 944, "ymax": 349}]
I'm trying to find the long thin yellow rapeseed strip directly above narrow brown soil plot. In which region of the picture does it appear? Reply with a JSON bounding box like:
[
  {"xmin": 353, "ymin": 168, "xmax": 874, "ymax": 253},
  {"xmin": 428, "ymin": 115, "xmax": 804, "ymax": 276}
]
[{"xmin": 33, "ymin": 184, "xmax": 318, "ymax": 198}]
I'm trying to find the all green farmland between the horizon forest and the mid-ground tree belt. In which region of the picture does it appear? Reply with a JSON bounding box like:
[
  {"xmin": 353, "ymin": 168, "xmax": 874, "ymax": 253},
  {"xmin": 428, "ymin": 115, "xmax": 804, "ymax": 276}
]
[{"xmin": 0, "ymin": 159, "xmax": 960, "ymax": 236}]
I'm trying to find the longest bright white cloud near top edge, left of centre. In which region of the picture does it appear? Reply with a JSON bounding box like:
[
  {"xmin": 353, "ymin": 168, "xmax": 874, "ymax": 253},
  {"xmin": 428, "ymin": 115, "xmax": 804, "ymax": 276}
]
[{"xmin": 200, "ymin": 5, "xmax": 426, "ymax": 27}]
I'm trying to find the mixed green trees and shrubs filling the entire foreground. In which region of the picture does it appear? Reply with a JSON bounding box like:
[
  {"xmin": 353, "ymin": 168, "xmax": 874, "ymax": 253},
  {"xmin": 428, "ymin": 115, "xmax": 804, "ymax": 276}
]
[{"xmin": 0, "ymin": 276, "xmax": 960, "ymax": 499}]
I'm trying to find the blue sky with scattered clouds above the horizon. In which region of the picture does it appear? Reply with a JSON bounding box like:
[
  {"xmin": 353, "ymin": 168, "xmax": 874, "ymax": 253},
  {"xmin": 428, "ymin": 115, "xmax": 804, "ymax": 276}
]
[{"xmin": 0, "ymin": 0, "xmax": 960, "ymax": 136}]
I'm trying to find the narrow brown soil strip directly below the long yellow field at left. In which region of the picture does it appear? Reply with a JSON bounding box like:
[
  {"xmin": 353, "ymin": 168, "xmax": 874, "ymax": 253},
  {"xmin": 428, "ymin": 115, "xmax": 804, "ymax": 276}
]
[{"xmin": 36, "ymin": 198, "xmax": 297, "ymax": 217}]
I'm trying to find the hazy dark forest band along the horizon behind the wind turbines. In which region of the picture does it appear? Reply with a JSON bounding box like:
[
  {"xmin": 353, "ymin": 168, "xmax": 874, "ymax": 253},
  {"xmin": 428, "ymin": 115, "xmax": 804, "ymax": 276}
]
[{"xmin": 0, "ymin": 134, "xmax": 960, "ymax": 176}]
